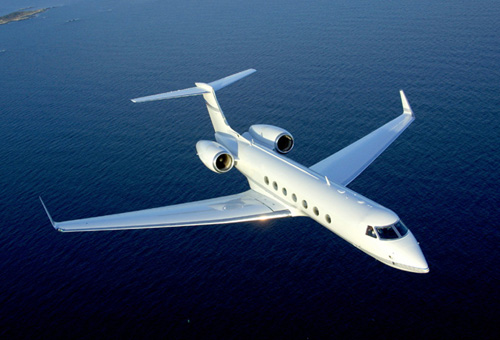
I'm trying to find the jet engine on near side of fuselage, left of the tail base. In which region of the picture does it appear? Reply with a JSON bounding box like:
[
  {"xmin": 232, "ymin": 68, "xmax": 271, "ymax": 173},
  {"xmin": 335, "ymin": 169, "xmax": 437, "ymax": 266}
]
[{"xmin": 196, "ymin": 140, "xmax": 234, "ymax": 174}]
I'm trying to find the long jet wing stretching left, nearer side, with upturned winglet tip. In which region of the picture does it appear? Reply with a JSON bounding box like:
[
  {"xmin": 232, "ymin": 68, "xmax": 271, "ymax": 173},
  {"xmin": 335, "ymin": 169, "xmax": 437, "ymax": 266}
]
[{"xmin": 40, "ymin": 190, "xmax": 292, "ymax": 232}]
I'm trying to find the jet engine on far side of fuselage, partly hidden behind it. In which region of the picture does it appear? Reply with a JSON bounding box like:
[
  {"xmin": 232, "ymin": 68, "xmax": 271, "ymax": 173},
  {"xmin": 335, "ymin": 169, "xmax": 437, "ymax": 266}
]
[{"xmin": 248, "ymin": 124, "xmax": 294, "ymax": 154}]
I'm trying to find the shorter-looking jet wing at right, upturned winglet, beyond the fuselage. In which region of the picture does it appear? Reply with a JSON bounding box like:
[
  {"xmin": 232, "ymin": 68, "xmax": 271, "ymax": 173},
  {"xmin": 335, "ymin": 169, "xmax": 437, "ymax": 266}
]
[{"xmin": 310, "ymin": 90, "xmax": 415, "ymax": 186}]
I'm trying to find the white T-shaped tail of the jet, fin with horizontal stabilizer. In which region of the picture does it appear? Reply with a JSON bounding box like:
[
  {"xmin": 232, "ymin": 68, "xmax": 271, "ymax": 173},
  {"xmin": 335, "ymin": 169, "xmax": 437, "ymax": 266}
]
[{"xmin": 132, "ymin": 69, "xmax": 255, "ymax": 134}]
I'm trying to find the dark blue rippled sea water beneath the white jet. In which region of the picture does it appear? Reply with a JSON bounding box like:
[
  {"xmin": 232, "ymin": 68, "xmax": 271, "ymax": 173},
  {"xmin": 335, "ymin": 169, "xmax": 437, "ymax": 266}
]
[{"xmin": 0, "ymin": 0, "xmax": 500, "ymax": 339}]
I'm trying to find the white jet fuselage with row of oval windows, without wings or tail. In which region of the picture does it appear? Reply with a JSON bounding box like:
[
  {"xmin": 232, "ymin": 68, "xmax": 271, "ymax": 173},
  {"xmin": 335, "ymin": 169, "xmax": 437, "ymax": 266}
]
[{"xmin": 216, "ymin": 133, "xmax": 428, "ymax": 272}]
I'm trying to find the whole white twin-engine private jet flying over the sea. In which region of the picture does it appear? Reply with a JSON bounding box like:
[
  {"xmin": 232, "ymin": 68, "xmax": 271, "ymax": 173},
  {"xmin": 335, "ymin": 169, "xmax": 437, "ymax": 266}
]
[{"xmin": 42, "ymin": 69, "xmax": 429, "ymax": 273}]
